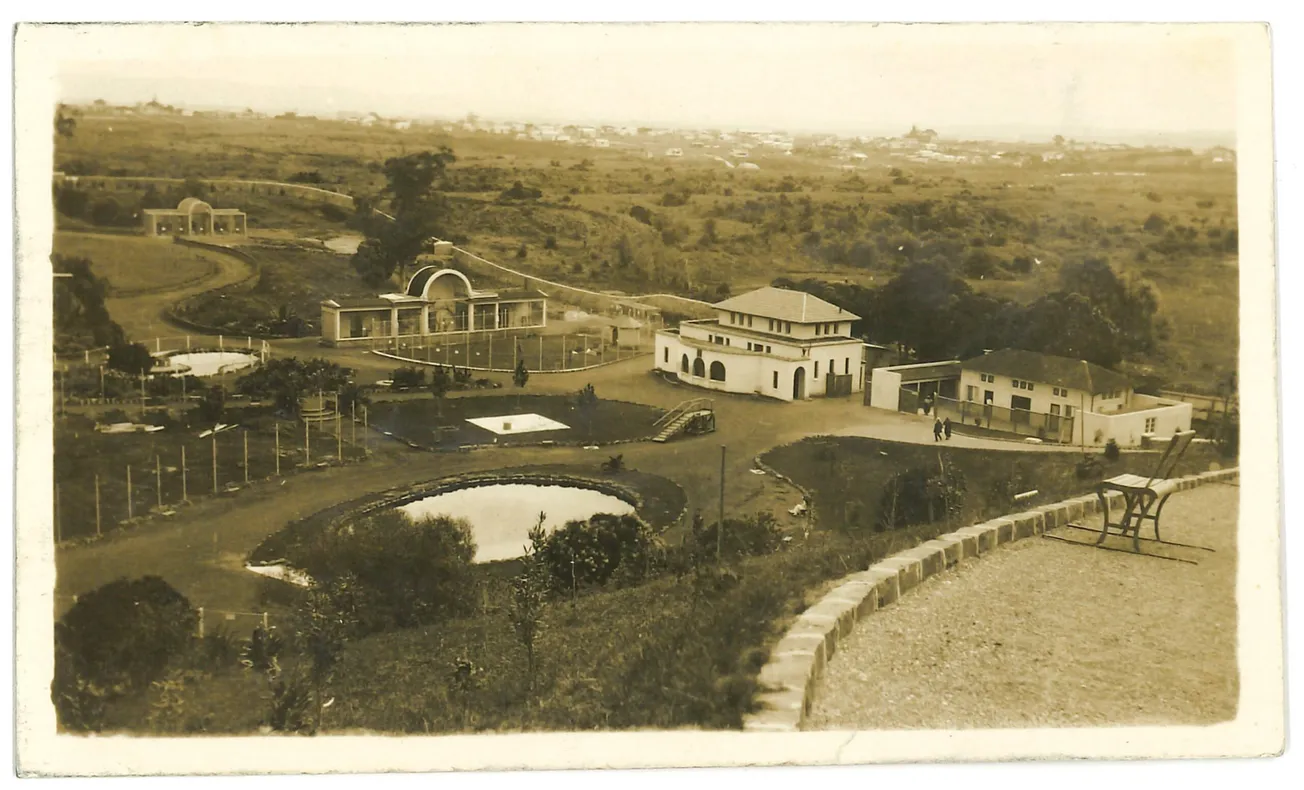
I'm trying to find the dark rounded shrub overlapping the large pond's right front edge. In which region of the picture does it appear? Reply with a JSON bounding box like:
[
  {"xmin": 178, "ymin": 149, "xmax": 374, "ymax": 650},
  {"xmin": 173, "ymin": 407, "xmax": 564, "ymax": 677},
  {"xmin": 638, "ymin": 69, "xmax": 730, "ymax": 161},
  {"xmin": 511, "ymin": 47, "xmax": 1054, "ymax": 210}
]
[{"xmin": 533, "ymin": 514, "xmax": 656, "ymax": 591}]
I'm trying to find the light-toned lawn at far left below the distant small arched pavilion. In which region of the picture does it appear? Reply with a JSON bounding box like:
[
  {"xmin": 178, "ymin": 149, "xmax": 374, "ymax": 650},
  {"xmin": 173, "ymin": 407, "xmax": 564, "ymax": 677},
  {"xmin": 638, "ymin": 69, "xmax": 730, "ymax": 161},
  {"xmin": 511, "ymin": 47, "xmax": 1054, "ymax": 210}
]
[{"xmin": 55, "ymin": 232, "xmax": 225, "ymax": 296}]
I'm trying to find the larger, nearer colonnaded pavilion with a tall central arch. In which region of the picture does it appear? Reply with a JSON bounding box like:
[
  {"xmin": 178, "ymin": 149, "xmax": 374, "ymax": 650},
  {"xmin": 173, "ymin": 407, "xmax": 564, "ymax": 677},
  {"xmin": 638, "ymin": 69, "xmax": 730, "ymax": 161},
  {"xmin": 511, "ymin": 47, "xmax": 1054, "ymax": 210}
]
[{"xmin": 322, "ymin": 259, "xmax": 548, "ymax": 345}]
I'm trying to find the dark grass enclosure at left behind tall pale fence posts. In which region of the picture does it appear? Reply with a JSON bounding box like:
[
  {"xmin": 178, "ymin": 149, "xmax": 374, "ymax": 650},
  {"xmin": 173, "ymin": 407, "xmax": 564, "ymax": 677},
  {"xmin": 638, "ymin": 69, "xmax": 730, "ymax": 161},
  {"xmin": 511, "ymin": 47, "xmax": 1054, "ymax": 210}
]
[{"xmin": 53, "ymin": 407, "xmax": 363, "ymax": 540}]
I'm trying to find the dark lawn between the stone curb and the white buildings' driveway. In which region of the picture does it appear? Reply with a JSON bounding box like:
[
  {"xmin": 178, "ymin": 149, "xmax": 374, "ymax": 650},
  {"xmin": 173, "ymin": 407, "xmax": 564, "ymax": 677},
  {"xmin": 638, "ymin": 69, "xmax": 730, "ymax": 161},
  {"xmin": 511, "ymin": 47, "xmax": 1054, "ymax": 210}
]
[{"xmin": 762, "ymin": 437, "xmax": 1235, "ymax": 528}]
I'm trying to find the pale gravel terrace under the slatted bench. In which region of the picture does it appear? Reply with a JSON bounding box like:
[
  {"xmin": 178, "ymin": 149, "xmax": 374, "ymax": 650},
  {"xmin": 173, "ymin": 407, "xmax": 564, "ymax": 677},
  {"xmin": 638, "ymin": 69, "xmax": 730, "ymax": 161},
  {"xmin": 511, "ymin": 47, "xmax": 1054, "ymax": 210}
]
[{"xmin": 806, "ymin": 485, "xmax": 1239, "ymax": 730}]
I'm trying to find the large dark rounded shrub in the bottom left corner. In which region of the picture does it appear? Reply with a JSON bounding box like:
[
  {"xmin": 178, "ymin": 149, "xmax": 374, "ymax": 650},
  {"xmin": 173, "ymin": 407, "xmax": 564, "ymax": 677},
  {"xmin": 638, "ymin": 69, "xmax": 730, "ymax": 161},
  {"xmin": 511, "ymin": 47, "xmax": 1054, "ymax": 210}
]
[{"xmin": 51, "ymin": 576, "xmax": 198, "ymax": 730}]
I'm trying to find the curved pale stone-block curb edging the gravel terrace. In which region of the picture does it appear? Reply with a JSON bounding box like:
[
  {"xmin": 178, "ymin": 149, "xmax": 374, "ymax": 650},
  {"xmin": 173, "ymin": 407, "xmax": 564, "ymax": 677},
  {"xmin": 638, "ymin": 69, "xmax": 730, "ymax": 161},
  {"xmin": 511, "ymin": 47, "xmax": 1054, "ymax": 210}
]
[{"xmin": 742, "ymin": 468, "xmax": 1240, "ymax": 733}]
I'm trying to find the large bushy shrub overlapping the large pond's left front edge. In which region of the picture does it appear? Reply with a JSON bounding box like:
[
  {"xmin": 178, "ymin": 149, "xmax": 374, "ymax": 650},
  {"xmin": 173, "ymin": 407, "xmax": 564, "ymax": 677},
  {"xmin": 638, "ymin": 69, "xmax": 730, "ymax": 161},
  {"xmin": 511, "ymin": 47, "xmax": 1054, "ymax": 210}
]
[{"xmin": 289, "ymin": 510, "xmax": 476, "ymax": 632}]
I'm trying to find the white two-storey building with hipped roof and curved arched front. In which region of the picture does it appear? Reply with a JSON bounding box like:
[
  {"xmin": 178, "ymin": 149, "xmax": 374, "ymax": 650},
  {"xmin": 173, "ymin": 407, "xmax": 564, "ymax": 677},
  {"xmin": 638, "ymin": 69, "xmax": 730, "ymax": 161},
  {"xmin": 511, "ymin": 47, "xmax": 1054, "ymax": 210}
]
[{"xmin": 655, "ymin": 287, "xmax": 865, "ymax": 400}]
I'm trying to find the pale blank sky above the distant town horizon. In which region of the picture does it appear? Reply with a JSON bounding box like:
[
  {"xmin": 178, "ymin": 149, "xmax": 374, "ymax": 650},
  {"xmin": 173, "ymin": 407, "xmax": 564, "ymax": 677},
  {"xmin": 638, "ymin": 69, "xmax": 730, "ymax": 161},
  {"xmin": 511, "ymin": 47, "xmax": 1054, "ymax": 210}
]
[{"xmin": 50, "ymin": 23, "xmax": 1236, "ymax": 144}]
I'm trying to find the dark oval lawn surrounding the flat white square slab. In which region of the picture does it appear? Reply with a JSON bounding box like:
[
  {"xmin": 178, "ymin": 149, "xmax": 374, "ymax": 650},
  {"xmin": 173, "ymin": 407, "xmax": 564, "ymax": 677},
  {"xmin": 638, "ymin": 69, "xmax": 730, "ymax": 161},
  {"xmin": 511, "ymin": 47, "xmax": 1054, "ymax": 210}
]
[{"xmin": 369, "ymin": 390, "xmax": 664, "ymax": 448}]
